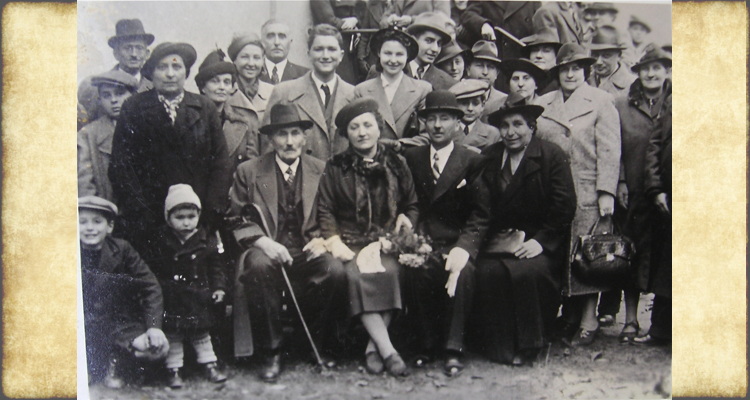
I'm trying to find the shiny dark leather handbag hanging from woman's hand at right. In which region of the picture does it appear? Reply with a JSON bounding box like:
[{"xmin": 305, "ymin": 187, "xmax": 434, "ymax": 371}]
[{"xmin": 570, "ymin": 217, "xmax": 635, "ymax": 286}]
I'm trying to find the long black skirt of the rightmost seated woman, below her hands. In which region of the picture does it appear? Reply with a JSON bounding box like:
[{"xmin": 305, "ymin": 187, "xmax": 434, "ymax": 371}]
[{"xmin": 476, "ymin": 254, "xmax": 561, "ymax": 364}]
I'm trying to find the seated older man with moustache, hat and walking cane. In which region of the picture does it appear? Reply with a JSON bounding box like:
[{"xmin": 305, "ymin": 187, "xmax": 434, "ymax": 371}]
[{"xmin": 229, "ymin": 101, "xmax": 347, "ymax": 382}]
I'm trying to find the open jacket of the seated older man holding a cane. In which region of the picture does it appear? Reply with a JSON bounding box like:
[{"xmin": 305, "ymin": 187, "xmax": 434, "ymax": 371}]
[{"xmin": 229, "ymin": 152, "xmax": 325, "ymax": 242}]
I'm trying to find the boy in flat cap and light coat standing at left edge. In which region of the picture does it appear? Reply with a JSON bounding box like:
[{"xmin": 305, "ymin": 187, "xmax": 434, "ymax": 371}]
[{"xmin": 78, "ymin": 70, "xmax": 138, "ymax": 200}]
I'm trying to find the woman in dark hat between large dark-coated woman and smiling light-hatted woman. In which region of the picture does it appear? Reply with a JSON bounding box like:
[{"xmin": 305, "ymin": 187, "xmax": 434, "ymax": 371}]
[{"xmin": 195, "ymin": 50, "xmax": 260, "ymax": 173}]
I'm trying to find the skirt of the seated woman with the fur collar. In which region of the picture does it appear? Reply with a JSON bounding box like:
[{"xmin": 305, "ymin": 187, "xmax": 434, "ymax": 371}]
[{"xmin": 345, "ymin": 246, "xmax": 403, "ymax": 317}]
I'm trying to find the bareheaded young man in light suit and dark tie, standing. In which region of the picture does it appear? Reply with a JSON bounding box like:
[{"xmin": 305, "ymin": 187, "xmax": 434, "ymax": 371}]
[{"xmin": 263, "ymin": 24, "xmax": 354, "ymax": 161}]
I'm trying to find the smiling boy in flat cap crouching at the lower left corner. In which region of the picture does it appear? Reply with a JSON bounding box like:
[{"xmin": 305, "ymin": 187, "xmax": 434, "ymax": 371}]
[{"xmin": 78, "ymin": 196, "xmax": 169, "ymax": 388}]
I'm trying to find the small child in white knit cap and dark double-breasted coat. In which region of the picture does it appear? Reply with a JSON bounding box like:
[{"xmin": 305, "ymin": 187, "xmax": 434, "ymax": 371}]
[{"xmin": 152, "ymin": 184, "xmax": 227, "ymax": 388}]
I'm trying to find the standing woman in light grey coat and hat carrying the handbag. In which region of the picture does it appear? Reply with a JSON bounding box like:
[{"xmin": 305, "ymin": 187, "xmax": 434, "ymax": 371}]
[{"xmin": 537, "ymin": 43, "xmax": 621, "ymax": 346}]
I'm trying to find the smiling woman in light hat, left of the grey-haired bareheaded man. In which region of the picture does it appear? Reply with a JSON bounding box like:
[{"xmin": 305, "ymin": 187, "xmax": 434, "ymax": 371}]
[{"xmin": 227, "ymin": 33, "xmax": 273, "ymax": 121}]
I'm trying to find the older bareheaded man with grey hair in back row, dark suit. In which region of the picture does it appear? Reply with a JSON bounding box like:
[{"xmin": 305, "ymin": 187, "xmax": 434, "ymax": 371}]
[{"xmin": 260, "ymin": 19, "xmax": 309, "ymax": 85}]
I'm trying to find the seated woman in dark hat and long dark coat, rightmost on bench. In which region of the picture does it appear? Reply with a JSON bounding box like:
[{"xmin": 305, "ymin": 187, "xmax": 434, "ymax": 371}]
[{"xmin": 467, "ymin": 100, "xmax": 576, "ymax": 366}]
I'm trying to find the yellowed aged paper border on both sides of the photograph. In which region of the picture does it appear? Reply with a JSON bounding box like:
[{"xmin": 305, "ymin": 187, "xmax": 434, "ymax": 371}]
[{"xmin": 2, "ymin": 2, "xmax": 748, "ymax": 398}]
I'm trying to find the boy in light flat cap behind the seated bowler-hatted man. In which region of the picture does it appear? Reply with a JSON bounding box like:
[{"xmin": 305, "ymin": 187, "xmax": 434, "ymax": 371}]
[{"xmin": 450, "ymin": 79, "xmax": 500, "ymax": 152}]
